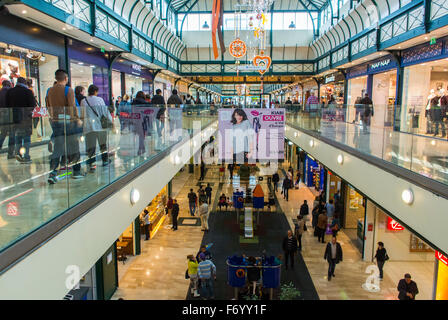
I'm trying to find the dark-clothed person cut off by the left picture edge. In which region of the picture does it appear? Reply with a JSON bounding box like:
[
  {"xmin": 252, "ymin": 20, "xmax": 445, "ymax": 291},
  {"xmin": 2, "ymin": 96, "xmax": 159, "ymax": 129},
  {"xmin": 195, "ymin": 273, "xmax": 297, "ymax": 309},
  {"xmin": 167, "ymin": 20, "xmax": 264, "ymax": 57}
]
[{"xmin": 0, "ymin": 80, "xmax": 15, "ymax": 159}]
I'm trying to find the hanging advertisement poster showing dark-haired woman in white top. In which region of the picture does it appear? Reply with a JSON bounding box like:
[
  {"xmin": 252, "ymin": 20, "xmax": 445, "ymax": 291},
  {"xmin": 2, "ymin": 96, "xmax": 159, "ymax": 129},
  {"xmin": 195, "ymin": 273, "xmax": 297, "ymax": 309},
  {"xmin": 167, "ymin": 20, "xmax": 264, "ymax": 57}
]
[{"xmin": 219, "ymin": 108, "xmax": 285, "ymax": 163}]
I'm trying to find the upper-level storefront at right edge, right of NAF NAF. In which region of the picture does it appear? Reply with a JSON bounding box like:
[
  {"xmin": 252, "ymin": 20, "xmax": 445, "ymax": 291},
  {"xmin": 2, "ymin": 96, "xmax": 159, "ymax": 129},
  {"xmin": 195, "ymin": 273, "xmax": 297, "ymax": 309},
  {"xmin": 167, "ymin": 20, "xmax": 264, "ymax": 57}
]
[{"xmin": 396, "ymin": 38, "xmax": 448, "ymax": 137}]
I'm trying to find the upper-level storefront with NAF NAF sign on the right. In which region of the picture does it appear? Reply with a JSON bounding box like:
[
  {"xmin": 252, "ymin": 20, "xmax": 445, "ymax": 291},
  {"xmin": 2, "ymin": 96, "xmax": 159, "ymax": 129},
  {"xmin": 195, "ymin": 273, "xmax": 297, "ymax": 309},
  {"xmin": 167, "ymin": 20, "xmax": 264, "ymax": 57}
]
[{"xmin": 347, "ymin": 56, "xmax": 398, "ymax": 127}]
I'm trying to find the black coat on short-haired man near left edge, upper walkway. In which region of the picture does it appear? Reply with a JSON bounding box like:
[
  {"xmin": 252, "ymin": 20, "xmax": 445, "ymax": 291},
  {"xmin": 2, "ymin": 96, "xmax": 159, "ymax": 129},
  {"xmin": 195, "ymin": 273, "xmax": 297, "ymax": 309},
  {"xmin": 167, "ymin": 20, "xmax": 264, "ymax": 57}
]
[{"xmin": 6, "ymin": 85, "xmax": 36, "ymax": 134}]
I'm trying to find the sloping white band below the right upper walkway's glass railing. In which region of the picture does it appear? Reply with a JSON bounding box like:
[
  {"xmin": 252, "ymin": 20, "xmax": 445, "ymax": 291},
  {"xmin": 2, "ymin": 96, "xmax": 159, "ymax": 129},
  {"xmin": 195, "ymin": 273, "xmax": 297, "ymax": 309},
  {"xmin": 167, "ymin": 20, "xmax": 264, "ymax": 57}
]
[{"xmin": 286, "ymin": 126, "xmax": 448, "ymax": 252}]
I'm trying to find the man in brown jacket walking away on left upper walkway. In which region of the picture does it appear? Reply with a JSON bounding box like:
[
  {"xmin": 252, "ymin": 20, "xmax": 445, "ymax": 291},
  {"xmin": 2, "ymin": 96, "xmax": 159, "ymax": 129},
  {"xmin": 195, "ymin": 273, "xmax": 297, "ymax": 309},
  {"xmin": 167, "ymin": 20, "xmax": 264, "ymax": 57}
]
[{"xmin": 45, "ymin": 69, "xmax": 84, "ymax": 184}]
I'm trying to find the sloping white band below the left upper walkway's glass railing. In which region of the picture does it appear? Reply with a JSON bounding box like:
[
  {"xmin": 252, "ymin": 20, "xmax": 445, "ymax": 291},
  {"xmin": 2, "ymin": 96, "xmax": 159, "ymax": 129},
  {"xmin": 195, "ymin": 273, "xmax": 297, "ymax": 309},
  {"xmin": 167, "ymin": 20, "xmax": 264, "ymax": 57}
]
[{"xmin": 0, "ymin": 123, "xmax": 217, "ymax": 300}]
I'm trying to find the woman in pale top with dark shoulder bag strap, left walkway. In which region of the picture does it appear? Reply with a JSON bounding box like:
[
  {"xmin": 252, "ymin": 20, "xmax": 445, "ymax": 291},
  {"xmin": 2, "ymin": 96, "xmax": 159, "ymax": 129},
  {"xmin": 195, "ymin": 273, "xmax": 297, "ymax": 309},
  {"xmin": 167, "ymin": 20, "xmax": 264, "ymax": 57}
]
[{"xmin": 81, "ymin": 84, "xmax": 113, "ymax": 172}]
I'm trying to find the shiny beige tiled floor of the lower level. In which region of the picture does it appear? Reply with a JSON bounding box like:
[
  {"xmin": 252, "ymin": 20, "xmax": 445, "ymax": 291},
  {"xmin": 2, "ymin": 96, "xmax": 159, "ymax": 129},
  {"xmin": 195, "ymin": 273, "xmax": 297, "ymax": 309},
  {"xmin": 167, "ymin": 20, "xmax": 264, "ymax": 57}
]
[{"xmin": 113, "ymin": 165, "xmax": 433, "ymax": 300}]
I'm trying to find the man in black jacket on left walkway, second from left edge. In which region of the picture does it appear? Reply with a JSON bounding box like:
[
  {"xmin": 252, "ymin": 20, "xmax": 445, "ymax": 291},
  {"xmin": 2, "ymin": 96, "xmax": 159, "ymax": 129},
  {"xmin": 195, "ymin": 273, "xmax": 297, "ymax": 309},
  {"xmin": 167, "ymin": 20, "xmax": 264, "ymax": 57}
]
[{"xmin": 6, "ymin": 77, "xmax": 36, "ymax": 163}]
